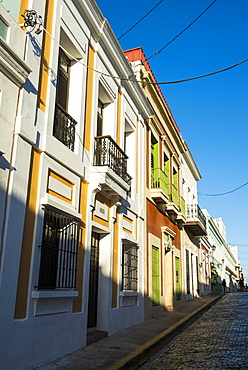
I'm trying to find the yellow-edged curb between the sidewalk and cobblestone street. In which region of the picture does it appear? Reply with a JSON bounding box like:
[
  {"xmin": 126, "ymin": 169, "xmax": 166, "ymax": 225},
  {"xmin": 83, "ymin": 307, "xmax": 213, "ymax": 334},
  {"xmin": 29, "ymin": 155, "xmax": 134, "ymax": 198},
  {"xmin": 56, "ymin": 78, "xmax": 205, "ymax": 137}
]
[{"xmin": 108, "ymin": 293, "xmax": 224, "ymax": 370}]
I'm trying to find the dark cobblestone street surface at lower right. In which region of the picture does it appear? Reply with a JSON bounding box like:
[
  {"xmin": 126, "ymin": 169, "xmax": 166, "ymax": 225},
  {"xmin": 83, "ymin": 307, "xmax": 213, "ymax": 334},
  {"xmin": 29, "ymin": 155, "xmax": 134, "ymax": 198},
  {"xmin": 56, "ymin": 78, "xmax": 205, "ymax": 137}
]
[{"xmin": 139, "ymin": 293, "xmax": 248, "ymax": 370}]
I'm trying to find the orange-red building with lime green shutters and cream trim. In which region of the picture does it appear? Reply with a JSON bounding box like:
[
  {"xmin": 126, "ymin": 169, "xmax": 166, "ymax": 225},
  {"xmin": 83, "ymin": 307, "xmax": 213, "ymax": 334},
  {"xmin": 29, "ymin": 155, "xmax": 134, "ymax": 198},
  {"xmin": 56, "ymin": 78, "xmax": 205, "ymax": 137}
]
[{"xmin": 125, "ymin": 47, "xmax": 186, "ymax": 318}]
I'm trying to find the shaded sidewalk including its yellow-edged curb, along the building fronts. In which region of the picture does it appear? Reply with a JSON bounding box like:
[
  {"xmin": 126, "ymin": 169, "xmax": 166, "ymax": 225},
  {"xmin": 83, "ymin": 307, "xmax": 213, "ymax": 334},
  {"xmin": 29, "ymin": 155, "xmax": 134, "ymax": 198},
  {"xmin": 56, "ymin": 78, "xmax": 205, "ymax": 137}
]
[{"xmin": 37, "ymin": 292, "xmax": 223, "ymax": 370}]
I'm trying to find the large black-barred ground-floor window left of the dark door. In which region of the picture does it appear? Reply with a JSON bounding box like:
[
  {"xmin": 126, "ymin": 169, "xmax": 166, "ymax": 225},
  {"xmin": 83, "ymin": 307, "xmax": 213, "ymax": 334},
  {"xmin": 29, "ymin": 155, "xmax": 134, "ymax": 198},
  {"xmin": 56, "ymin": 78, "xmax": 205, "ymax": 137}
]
[{"xmin": 38, "ymin": 206, "xmax": 79, "ymax": 289}]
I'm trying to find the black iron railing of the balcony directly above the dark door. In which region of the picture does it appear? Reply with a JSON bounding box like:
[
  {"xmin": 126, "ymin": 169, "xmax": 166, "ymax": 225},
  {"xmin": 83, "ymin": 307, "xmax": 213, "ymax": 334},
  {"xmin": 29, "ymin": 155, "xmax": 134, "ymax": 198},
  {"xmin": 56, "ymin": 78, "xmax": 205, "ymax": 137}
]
[{"xmin": 94, "ymin": 135, "xmax": 131, "ymax": 184}]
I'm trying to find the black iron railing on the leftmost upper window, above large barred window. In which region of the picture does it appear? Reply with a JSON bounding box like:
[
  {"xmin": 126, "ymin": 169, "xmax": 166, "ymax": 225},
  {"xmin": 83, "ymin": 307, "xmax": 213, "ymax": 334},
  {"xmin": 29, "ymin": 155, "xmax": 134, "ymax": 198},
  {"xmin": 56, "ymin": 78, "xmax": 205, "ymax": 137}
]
[{"xmin": 53, "ymin": 104, "xmax": 77, "ymax": 151}]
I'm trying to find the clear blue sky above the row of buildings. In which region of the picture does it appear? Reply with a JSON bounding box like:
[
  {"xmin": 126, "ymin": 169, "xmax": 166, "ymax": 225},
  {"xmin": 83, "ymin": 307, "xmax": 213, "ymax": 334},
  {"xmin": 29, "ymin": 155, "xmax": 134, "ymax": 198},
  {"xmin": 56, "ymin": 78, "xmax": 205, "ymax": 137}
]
[{"xmin": 97, "ymin": 0, "xmax": 248, "ymax": 277}]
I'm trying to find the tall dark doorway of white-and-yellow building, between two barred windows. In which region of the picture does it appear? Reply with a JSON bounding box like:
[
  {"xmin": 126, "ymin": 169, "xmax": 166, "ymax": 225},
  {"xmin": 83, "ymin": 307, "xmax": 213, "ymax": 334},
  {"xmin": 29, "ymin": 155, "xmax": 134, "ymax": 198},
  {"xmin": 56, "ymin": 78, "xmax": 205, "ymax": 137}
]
[{"xmin": 88, "ymin": 232, "xmax": 100, "ymax": 328}]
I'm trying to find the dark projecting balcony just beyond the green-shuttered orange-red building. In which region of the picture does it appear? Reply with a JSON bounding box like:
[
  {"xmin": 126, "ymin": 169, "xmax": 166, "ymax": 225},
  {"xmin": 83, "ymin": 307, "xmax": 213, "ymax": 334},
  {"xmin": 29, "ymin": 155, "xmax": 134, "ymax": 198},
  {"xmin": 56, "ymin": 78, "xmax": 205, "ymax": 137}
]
[{"xmin": 184, "ymin": 204, "xmax": 207, "ymax": 236}]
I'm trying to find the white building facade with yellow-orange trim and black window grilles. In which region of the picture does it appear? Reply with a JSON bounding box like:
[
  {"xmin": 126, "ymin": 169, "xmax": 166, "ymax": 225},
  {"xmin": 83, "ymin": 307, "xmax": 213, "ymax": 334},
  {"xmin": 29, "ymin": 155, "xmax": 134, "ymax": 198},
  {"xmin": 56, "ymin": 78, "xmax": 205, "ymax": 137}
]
[{"xmin": 0, "ymin": 0, "xmax": 150, "ymax": 369}]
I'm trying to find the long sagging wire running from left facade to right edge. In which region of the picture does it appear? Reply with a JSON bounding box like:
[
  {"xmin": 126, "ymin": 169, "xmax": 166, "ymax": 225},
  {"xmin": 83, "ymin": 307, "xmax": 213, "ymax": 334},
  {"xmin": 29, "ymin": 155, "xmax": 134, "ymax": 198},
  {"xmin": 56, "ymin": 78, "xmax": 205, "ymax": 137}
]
[{"xmin": 43, "ymin": 28, "xmax": 248, "ymax": 85}]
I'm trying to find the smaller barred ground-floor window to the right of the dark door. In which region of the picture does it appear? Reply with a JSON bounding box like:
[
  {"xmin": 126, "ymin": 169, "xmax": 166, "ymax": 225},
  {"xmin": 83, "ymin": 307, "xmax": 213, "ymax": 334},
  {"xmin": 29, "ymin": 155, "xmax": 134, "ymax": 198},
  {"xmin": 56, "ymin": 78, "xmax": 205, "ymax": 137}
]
[{"xmin": 122, "ymin": 242, "xmax": 138, "ymax": 292}]
